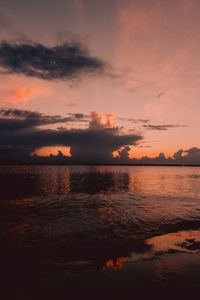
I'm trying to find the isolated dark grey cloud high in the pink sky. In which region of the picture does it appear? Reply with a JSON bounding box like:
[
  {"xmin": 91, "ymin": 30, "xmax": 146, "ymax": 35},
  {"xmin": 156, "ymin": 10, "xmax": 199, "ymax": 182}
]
[{"xmin": 0, "ymin": 42, "xmax": 105, "ymax": 80}]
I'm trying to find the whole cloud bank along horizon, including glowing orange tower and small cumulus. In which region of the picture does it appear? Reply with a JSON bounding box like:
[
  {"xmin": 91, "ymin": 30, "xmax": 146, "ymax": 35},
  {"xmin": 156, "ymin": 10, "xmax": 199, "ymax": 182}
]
[{"xmin": 0, "ymin": 109, "xmax": 200, "ymax": 165}]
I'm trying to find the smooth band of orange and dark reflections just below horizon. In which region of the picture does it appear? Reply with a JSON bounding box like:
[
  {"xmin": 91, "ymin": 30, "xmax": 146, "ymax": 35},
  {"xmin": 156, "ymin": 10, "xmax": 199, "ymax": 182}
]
[{"xmin": 0, "ymin": 166, "xmax": 200, "ymax": 198}]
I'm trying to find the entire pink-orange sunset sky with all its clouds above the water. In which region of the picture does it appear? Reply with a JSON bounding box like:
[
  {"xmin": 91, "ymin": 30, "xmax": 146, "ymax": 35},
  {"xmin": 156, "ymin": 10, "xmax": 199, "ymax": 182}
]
[{"xmin": 0, "ymin": 0, "xmax": 200, "ymax": 164}]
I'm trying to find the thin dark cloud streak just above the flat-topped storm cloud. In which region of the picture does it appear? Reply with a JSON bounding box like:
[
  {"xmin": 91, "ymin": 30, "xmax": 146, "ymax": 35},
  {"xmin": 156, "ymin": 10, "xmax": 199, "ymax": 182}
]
[{"xmin": 0, "ymin": 109, "xmax": 88, "ymax": 130}]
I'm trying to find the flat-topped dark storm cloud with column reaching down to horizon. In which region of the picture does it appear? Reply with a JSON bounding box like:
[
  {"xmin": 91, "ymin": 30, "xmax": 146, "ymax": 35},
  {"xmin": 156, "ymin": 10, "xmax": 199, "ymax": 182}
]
[{"xmin": 0, "ymin": 129, "xmax": 142, "ymax": 163}]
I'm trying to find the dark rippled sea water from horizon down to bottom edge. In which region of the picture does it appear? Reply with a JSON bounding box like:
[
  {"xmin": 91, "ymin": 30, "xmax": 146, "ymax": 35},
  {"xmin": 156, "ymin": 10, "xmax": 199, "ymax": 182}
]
[{"xmin": 0, "ymin": 166, "xmax": 200, "ymax": 300}]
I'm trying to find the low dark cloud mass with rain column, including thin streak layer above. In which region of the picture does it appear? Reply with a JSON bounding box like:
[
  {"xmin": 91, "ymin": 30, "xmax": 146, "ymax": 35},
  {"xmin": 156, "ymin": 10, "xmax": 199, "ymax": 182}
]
[{"xmin": 0, "ymin": 109, "xmax": 142, "ymax": 163}]
